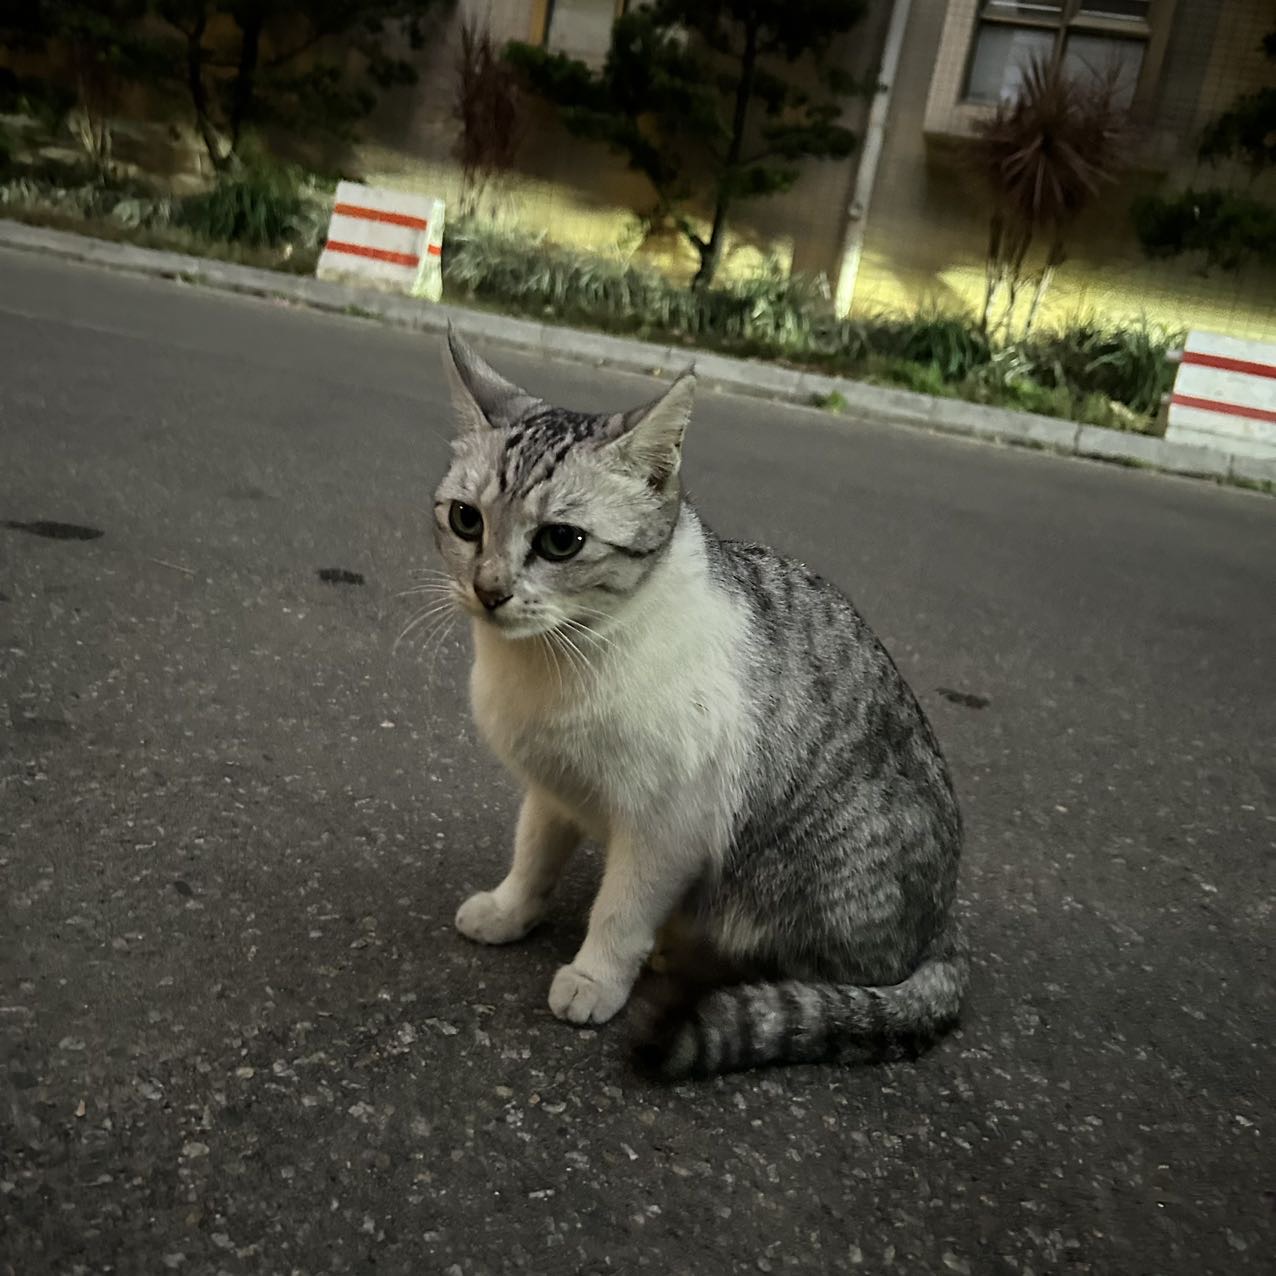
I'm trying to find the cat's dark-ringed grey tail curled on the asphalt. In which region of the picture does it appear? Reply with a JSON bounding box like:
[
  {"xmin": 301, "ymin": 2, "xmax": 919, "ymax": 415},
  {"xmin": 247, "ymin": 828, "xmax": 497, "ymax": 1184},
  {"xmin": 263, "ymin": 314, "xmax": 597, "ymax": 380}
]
[{"xmin": 635, "ymin": 924, "xmax": 970, "ymax": 1081}]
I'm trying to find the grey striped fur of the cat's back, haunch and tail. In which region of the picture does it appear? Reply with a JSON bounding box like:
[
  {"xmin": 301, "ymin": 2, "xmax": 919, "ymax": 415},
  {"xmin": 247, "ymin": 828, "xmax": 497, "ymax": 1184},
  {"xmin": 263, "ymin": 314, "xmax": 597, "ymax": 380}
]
[{"xmin": 638, "ymin": 530, "xmax": 968, "ymax": 1078}]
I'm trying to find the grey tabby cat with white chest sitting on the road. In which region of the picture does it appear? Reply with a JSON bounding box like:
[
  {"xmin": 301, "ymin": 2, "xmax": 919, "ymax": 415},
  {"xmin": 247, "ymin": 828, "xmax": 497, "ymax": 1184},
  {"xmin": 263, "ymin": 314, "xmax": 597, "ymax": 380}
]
[{"xmin": 434, "ymin": 332, "xmax": 967, "ymax": 1078}]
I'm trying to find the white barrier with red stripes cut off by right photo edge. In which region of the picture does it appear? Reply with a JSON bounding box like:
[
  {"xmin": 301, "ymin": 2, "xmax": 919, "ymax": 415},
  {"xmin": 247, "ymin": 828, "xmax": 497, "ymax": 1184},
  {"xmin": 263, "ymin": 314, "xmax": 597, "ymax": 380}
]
[{"xmin": 1165, "ymin": 332, "xmax": 1276, "ymax": 459}]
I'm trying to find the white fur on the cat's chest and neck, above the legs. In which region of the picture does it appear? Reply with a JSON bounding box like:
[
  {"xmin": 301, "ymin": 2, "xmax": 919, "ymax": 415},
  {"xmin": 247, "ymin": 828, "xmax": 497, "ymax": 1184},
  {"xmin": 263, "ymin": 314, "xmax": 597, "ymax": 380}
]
[{"xmin": 471, "ymin": 528, "xmax": 753, "ymax": 854}]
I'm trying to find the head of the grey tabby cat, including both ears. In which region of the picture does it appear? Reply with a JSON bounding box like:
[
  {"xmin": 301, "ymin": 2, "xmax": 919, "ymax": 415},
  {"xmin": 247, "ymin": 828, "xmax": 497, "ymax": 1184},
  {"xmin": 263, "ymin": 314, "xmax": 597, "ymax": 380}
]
[{"xmin": 434, "ymin": 330, "xmax": 695, "ymax": 638}]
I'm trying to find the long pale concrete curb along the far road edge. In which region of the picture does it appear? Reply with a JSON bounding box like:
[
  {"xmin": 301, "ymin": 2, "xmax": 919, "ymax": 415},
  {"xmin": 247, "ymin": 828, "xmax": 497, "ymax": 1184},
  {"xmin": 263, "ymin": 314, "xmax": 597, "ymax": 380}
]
[{"xmin": 0, "ymin": 221, "xmax": 1276, "ymax": 486}]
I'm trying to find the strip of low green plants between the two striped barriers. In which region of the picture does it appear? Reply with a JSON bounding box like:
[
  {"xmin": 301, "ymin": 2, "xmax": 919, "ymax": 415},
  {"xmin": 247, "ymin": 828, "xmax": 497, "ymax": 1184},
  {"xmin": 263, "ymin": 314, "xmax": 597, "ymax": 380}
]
[{"xmin": 443, "ymin": 215, "xmax": 1182, "ymax": 429}]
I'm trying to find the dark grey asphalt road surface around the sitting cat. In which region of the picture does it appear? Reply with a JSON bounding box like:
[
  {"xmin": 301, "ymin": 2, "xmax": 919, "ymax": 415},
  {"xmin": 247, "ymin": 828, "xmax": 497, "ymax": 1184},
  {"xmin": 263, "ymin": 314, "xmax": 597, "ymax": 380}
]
[{"xmin": 0, "ymin": 254, "xmax": 1276, "ymax": 1276}]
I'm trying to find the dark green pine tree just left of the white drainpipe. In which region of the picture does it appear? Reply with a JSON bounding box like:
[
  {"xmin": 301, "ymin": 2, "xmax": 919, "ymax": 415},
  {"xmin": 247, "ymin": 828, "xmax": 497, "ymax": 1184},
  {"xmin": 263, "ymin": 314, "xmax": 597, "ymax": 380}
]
[{"xmin": 507, "ymin": 0, "xmax": 864, "ymax": 287}]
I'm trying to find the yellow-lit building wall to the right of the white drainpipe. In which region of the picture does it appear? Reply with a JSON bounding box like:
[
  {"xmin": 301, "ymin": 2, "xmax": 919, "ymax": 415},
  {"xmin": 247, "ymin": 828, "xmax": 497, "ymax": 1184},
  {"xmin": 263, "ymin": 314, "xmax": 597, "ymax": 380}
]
[{"xmin": 854, "ymin": 0, "xmax": 1276, "ymax": 341}]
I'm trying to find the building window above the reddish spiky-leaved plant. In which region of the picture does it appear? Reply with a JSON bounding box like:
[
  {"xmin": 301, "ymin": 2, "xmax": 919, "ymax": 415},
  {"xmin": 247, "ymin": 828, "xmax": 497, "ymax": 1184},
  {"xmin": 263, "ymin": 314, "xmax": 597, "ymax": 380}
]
[{"xmin": 965, "ymin": 0, "xmax": 1152, "ymax": 107}]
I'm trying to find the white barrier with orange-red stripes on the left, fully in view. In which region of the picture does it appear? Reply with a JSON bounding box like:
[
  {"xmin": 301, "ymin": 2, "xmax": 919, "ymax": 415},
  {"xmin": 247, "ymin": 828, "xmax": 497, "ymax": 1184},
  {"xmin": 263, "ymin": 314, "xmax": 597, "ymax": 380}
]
[{"xmin": 315, "ymin": 181, "xmax": 443, "ymax": 301}]
